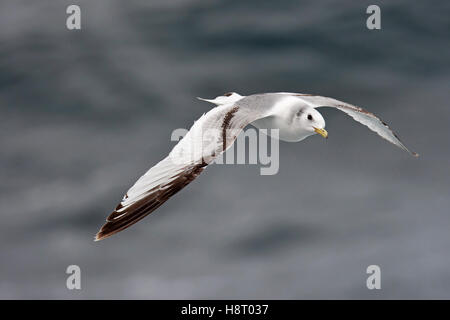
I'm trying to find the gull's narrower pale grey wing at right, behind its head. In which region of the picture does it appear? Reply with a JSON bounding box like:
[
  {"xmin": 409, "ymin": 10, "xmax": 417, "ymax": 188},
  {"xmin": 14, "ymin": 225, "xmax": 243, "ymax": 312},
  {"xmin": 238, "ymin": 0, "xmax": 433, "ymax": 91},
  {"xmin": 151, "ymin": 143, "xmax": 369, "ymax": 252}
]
[{"xmin": 292, "ymin": 94, "xmax": 419, "ymax": 157}]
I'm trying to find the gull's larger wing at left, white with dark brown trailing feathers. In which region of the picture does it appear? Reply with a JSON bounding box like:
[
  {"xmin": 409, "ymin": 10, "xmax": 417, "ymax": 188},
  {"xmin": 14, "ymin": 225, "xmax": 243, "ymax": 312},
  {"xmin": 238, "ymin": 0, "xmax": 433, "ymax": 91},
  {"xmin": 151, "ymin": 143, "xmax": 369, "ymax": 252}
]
[{"xmin": 95, "ymin": 100, "xmax": 270, "ymax": 241}]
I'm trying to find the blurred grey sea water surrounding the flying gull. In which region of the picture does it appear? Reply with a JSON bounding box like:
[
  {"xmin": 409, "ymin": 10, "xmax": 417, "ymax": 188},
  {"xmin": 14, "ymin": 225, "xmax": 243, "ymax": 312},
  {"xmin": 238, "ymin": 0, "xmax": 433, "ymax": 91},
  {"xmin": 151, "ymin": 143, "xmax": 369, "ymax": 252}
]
[{"xmin": 0, "ymin": 0, "xmax": 450, "ymax": 299}]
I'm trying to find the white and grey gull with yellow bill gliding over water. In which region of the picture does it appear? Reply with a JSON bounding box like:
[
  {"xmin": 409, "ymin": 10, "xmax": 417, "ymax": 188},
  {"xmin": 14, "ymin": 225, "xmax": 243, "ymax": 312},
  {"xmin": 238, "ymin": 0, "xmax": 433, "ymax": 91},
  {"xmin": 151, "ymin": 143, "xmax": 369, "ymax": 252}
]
[{"xmin": 95, "ymin": 92, "xmax": 418, "ymax": 241}]
